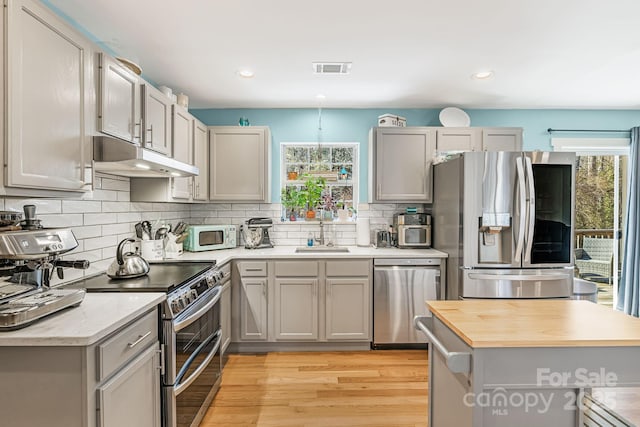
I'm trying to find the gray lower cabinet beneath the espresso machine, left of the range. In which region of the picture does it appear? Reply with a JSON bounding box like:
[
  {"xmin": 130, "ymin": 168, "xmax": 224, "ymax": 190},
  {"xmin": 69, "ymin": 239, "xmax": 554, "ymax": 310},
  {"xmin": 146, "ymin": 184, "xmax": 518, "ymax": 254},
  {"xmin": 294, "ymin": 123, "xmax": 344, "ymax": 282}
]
[{"xmin": 0, "ymin": 309, "xmax": 161, "ymax": 427}]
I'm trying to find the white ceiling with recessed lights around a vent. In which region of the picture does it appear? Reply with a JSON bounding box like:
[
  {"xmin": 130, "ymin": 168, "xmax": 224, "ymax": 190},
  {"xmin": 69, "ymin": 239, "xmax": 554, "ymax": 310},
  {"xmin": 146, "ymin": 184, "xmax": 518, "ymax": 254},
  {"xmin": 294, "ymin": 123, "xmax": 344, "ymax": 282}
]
[{"xmin": 49, "ymin": 0, "xmax": 640, "ymax": 109}]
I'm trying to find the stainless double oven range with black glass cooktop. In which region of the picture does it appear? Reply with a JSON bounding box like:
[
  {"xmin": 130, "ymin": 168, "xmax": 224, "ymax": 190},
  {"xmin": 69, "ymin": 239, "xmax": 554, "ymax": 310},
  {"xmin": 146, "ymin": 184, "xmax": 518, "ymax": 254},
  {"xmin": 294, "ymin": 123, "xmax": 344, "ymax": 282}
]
[{"xmin": 71, "ymin": 262, "xmax": 227, "ymax": 427}]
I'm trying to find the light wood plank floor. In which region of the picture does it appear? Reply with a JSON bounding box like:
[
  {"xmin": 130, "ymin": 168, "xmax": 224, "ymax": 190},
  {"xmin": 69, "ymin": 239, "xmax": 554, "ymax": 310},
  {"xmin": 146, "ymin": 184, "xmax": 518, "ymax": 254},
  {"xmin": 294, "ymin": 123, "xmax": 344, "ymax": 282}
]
[{"xmin": 201, "ymin": 350, "xmax": 427, "ymax": 427}]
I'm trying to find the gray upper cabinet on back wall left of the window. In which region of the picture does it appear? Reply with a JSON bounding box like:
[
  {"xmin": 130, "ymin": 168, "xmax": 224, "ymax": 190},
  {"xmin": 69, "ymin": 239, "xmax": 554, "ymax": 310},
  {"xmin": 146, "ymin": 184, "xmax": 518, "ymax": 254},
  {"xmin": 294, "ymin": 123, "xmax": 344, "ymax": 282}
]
[{"xmin": 209, "ymin": 126, "xmax": 271, "ymax": 203}]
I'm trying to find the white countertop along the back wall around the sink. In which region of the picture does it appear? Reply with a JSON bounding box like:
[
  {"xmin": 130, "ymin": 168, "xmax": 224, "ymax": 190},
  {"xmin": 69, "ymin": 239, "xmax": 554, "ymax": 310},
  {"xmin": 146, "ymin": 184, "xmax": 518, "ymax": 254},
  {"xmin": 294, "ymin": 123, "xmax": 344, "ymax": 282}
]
[{"xmin": 162, "ymin": 246, "xmax": 447, "ymax": 265}]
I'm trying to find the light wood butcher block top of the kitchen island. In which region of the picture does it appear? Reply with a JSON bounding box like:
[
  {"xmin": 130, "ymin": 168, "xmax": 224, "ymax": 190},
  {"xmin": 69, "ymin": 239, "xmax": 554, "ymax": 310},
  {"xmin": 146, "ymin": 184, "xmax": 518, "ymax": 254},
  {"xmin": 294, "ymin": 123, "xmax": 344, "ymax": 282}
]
[{"xmin": 427, "ymin": 300, "xmax": 640, "ymax": 348}]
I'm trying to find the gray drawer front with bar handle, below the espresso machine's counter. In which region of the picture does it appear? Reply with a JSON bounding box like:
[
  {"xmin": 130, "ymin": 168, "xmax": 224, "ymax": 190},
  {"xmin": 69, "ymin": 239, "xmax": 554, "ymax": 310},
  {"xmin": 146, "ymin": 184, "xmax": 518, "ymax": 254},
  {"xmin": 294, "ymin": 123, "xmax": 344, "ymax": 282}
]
[{"xmin": 96, "ymin": 310, "xmax": 158, "ymax": 381}]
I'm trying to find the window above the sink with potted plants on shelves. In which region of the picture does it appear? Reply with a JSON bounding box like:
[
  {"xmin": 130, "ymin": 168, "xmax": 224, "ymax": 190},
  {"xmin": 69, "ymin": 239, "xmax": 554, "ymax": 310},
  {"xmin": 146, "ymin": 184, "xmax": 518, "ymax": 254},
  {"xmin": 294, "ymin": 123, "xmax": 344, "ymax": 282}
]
[{"xmin": 280, "ymin": 142, "xmax": 358, "ymax": 221}]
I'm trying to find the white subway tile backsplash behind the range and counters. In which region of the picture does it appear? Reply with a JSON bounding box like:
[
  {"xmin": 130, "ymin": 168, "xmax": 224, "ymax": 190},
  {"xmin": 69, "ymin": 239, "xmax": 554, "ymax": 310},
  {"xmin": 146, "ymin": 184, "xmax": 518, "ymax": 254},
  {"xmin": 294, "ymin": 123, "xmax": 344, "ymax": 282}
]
[{"xmin": 0, "ymin": 174, "xmax": 430, "ymax": 284}]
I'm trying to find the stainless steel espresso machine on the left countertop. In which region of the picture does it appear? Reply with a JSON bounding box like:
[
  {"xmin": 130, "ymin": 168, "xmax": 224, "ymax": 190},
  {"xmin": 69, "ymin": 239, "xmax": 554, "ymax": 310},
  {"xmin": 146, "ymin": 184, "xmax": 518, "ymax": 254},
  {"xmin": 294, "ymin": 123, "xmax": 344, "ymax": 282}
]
[{"xmin": 0, "ymin": 228, "xmax": 89, "ymax": 330}]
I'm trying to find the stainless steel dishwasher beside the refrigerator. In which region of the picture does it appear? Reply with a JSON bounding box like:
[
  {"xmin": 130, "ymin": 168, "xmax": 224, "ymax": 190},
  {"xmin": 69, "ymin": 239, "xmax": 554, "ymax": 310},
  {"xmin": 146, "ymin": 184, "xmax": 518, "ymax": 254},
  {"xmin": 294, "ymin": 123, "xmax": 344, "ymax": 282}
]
[{"xmin": 373, "ymin": 258, "xmax": 445, "ymax": 348}]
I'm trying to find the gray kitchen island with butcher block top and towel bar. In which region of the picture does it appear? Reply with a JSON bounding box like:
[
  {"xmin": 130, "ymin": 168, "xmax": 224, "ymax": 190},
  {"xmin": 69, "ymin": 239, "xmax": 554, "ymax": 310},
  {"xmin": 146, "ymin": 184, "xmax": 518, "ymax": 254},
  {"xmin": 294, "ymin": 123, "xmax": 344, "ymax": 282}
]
[{"xmin": 420, "ymin": 300, "xmax": 640, "ymax": 427}]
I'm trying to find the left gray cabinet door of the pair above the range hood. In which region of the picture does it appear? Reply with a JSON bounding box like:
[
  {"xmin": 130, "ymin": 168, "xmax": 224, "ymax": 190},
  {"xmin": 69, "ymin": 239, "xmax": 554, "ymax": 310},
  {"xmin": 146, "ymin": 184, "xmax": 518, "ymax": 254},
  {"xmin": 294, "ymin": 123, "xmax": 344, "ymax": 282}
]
[{"xmin": 98, "ymin": 53, "xmax": 142, "ymax": 143}]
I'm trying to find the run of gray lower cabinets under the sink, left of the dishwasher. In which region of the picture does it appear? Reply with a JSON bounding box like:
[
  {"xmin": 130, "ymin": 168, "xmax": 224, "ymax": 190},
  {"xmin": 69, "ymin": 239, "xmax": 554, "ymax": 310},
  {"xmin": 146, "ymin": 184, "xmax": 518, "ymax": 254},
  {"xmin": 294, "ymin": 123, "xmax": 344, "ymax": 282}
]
[{"xmin": 231, "ymin": 259, "xmax": 372, "ymax": 343}]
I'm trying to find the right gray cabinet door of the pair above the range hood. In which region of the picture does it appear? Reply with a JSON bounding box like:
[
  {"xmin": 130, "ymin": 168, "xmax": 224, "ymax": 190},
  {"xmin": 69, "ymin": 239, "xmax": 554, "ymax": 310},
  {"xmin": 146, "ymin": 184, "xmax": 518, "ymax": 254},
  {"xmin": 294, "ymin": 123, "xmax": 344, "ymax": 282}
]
[{"xmin": 142, "ymin": 83, "xmax": 172, "ymax": 156}]
